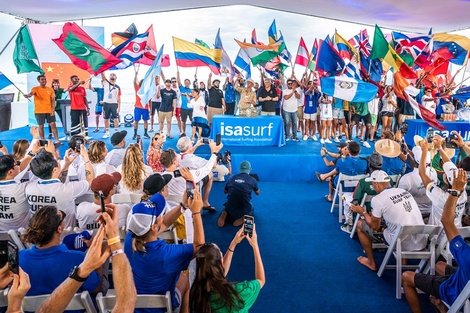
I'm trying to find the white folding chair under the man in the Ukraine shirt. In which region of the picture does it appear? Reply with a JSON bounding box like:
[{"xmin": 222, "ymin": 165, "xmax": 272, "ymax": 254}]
[{"xmin": 377, "ymin": 225, "xmax": 442, "ymax": 299}]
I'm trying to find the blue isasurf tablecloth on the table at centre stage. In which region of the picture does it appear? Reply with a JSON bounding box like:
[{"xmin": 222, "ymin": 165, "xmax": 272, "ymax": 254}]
[{"xmin": 211, "ymin": 115, "xmax": 286, "ymax": 147}]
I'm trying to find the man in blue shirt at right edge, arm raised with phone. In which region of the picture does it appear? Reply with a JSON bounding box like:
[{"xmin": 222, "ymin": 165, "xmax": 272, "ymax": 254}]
[{"xmin": 402, "ymin": 169, "xmax": 470, "ymax": 313}]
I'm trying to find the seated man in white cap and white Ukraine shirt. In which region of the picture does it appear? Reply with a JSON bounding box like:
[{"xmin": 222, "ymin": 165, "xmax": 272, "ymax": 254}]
[{"xmin": 351, "ymin": 170, "xmax": 427, "ymax": 271}]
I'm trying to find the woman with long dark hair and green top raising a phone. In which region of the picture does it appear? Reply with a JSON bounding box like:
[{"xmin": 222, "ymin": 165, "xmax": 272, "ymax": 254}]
[{"xmin": 181, "ymin": 226, "xmax": 266, "ymax": 313}]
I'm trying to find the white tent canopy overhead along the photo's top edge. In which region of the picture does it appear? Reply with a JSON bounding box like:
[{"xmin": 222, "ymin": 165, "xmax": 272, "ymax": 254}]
[{"xmin": 0, "ymin": 0, "xmax": 470, "ymax": 33}]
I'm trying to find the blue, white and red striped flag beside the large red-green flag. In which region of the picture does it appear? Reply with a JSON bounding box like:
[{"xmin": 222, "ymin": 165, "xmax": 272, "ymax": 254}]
[{"xmin": 111, "ymin": 33, "xmax": 149, "ymax": 70}]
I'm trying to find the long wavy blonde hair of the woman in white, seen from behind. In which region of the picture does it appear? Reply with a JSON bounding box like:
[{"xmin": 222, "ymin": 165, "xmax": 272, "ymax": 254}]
[{"xmin": 122, "ymin": 144, "xmax": 145, "ymax": 191}]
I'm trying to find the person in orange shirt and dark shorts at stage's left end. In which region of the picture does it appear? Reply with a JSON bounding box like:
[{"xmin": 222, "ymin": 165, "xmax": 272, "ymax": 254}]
[{"xmin": 25, "ymin": 75, "xmax": 60, "ymax": 143}]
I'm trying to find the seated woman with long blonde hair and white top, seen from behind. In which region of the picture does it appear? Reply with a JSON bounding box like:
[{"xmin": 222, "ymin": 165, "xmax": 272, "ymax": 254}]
[{"xmin": 117, "ymin": 144, "xmax": 153, "ymax": 193}]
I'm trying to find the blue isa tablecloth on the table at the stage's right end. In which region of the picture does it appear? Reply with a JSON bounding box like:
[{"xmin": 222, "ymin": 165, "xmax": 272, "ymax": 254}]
[{"xmin": 405, "ymin": 120, "xmax": 470, "ymax": 146}]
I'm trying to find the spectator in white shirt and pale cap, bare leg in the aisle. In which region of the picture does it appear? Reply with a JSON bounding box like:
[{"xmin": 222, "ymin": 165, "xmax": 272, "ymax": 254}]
[{"xmin": 176, "ymin": 137, "xmax": 215, "ymax": 212}]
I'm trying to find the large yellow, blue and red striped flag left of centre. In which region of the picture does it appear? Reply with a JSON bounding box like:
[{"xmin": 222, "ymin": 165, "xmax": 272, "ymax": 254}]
[{"xmin": 173, "ymin": 37, "xmax": 222, "ymax": 75}]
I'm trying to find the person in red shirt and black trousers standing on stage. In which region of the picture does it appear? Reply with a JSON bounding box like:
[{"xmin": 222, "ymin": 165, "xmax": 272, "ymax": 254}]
[{"xmin": 68, "ymin": 75, "xmax": 90, "ymax": 136}]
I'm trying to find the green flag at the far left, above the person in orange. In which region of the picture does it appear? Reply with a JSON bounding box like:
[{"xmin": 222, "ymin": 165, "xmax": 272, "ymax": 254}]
[{"xmin": 13, "ymin": 25, "xmax": 44, "ymax": 74}]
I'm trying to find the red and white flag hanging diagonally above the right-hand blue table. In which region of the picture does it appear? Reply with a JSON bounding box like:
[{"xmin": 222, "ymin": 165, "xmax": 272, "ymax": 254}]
[{"xmin": 393, "ymin": 72, "xmax": 445, "ymax": 130}]
